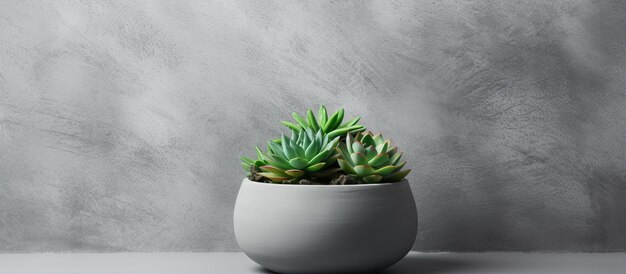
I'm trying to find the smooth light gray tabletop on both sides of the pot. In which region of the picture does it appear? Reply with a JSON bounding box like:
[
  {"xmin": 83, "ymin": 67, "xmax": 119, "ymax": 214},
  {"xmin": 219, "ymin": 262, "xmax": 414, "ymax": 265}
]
[{"xmin": 0, "ymin": 252, "xmax": 626, "ymax": 274}]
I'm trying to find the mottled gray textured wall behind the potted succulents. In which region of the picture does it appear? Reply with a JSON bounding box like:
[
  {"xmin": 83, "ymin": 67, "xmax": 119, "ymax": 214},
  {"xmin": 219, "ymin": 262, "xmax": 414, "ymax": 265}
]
[{"xmin": 0, "ymin": 1, "xmax": 626, "ymax": 252}]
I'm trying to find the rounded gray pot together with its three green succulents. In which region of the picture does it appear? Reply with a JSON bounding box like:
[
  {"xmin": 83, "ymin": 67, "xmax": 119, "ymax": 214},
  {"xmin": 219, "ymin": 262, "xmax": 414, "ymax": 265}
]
[{"xmin": 234, "ymin": 105, "xmax": 417, "ymax": 273}]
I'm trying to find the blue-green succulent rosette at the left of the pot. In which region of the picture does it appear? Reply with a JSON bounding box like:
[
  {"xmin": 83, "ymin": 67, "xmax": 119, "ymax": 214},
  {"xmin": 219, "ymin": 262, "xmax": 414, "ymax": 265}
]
[{"xmin": 241, "ymin": 128, "xmax": 341, "ymax": 183}]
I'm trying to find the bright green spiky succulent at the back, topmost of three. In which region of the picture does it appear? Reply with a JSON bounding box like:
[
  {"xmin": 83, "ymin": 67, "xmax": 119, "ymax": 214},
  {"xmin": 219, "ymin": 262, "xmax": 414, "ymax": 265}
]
[{"xmin": 281, "ymin": 105, "xmax": 365, "ymax": 139}]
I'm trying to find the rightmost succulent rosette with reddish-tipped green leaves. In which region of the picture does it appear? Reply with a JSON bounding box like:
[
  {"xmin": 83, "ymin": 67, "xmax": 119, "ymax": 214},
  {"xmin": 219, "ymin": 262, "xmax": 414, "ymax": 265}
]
[{"xmin": 337, "ymin": 132, "xmax": 411, "ymax": 184}]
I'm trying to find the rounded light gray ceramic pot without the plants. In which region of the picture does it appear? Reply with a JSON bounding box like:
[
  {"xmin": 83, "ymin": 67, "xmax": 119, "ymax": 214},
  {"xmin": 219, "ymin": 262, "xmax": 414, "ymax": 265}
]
[{"xmin": 234, "ymin": 179, "xmax": 417, "ymax": 273}]
